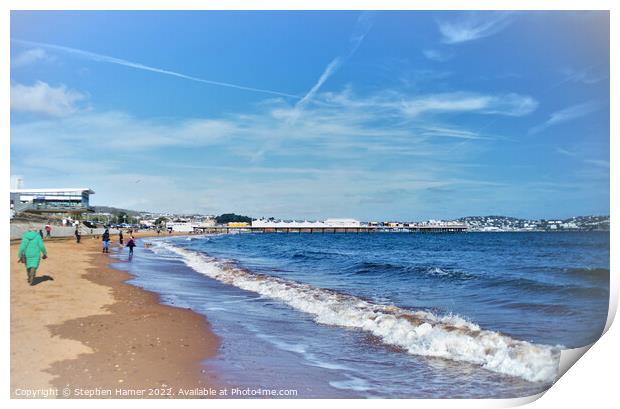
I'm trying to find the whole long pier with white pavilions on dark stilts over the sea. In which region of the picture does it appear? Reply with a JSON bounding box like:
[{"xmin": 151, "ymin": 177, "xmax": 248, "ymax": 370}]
[{"xmin": 194, "ymin": 219, "xmax": 467, "ymax": 233}]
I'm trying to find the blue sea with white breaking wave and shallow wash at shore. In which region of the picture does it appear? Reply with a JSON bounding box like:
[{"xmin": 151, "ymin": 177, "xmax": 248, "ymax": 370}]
[{"xmin": 112, "ymin": 232, "xmax": 609, "ymax": 398}]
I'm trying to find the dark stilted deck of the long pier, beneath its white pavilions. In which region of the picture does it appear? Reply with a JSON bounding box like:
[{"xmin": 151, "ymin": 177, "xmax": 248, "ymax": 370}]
[{"xmin": 194, "ymin": 224, "xmax": 467, "ymax": 234}]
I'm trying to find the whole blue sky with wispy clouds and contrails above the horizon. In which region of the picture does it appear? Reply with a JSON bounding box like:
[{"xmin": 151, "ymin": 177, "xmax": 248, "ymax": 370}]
[{"xmin": 10, "ymin": 11, "xmax": 610, "ymax": 221}]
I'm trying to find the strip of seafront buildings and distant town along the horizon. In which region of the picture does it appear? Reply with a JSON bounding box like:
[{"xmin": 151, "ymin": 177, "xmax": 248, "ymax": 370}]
[{"xmin": 10, "ymin": 179, "xmax": 610, "ymax": 232}]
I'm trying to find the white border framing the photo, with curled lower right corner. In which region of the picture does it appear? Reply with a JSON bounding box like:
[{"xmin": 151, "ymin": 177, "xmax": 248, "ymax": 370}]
[{"xmin": 0, "ymin": 0, "xmax": 620, "ymax": 408}]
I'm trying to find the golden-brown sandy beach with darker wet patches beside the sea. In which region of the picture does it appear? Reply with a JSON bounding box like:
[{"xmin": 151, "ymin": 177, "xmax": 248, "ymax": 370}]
[{"xmin": 10, "ymin": 234, "xmax": 218, "ymax": 398}]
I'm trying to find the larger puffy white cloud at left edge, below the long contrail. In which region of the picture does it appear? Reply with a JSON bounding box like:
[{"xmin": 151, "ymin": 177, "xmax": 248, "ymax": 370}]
[{"xmin": 11, "ymin": 81, "xmax": 86, "ymax": 117}]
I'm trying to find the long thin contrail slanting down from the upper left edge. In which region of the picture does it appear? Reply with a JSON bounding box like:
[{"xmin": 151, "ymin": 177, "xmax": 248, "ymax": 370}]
[{"xmin": 11, "ymin": 39, "xmax": 299, "ymax": 99}]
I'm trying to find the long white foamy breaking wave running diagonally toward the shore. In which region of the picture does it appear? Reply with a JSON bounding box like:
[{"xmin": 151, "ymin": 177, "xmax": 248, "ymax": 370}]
[{"xmin": 156, "ymin": 239, "xmax": 560, "ymax": 383}]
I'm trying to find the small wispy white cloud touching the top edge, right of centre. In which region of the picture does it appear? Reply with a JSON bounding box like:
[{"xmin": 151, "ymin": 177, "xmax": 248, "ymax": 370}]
[{"xmin": 437, "ymin": 12, "xmax": 511, "ymax": 44}]
